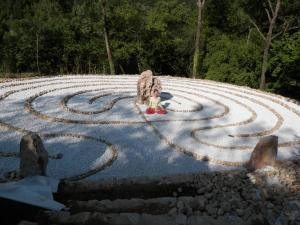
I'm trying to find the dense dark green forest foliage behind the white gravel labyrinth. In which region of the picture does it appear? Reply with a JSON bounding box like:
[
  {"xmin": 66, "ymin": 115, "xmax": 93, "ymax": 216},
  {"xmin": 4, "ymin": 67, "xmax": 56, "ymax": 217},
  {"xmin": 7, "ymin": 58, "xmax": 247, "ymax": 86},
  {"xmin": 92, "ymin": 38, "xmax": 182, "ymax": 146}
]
[{"xmin": 0, "ymin": 0, "xmax": 300, "ymax": 98}]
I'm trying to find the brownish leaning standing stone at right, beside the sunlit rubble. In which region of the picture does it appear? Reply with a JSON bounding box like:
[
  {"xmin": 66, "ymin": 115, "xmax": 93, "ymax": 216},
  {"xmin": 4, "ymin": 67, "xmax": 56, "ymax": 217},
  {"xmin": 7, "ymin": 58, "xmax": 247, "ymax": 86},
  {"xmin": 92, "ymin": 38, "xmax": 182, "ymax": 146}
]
[{"xmin": 248, "ymin": 135, "xmax": 278, "ymax": 170}]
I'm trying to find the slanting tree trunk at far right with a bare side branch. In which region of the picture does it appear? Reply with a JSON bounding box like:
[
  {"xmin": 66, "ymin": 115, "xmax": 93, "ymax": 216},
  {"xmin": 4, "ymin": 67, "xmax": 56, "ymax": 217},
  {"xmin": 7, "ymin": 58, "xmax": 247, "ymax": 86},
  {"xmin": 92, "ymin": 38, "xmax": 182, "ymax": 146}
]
[{"xmin": 259, "ymin": 0, "xmax": 280, "ymax": 89}]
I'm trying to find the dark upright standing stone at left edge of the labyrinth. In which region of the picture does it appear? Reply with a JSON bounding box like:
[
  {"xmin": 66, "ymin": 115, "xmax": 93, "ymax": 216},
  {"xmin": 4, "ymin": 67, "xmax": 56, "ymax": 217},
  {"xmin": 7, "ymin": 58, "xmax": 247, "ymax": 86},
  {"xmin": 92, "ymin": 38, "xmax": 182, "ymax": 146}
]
[{"xmin": 20, "ymin": 133, "xmax": 48, "ymax": 177}]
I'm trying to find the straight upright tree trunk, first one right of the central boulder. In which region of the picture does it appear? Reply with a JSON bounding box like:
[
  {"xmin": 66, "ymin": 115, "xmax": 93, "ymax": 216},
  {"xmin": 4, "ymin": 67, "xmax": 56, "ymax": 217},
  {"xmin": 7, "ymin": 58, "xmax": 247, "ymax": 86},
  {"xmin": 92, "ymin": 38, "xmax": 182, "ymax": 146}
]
[{"xmin": 192, "ymin": 0, "xmax": 205, "ymax": 79}]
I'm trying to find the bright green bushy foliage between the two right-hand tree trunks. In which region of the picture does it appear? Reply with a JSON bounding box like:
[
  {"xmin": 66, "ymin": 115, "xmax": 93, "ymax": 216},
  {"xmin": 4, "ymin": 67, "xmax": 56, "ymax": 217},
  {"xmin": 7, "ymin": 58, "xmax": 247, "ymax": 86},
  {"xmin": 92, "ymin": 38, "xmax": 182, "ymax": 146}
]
[{"xmin": 204, "ymin": 34, "xmax": 260, "ymax": 87}]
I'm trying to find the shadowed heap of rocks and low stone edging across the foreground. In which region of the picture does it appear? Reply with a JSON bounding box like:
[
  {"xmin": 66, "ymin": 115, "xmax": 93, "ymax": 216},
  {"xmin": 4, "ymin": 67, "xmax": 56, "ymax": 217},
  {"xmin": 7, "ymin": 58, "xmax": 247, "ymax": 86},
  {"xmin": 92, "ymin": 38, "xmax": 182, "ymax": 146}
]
[{"xmin": 33, "ymin": 160, "xmax": 300, "ymax": 225}]
